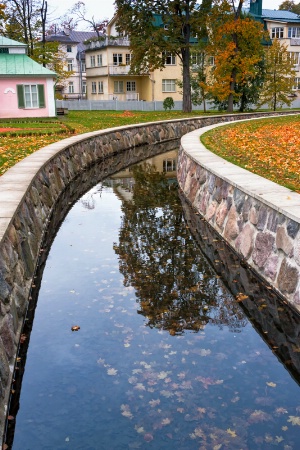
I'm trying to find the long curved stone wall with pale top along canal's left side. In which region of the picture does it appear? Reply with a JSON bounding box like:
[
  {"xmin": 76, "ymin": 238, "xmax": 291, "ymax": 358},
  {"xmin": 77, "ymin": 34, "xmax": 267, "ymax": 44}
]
[{"xmin": 0, "ymin": 113, "xmax": 298, "ymax": 442}]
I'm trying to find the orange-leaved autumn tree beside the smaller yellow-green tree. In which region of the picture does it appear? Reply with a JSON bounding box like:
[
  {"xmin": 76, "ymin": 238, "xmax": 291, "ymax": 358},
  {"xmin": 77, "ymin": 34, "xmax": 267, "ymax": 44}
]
[{"xmin": 207, "ymin": 0, "xmax": 265, "ymax": 112}]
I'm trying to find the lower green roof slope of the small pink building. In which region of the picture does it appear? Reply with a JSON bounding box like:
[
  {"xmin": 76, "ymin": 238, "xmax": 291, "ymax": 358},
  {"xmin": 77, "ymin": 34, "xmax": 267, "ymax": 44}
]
[{"xmin": 0, "ymin": 53, "xmax": 56, "ymax": 77}]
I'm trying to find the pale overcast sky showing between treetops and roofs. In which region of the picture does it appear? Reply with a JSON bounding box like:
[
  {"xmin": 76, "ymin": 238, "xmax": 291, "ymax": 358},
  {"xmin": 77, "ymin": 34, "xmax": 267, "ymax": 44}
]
[{"xmin": 48, "ymin": 0, "xmax": 286, "ymax": 30}]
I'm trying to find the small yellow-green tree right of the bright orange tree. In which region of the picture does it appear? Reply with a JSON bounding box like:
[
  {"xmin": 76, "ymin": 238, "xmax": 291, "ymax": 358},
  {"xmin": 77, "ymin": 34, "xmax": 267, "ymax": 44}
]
[{"xmin": 260, "ymin": 39, "xmax": 296, "ymax": 111}]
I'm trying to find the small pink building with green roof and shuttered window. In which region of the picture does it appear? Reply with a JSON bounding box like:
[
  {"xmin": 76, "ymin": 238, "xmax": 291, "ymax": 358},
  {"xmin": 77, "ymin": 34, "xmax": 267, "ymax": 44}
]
[{"xmin": 0, "ymin": 36, "xmax": 56, "ymax": 119}]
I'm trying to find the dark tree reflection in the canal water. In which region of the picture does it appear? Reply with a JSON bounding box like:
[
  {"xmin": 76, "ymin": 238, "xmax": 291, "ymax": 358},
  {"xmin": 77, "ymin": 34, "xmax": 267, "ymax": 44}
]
[{"xmin": 114, "ymin": 163, "xmax": 246, "ymax": 335}]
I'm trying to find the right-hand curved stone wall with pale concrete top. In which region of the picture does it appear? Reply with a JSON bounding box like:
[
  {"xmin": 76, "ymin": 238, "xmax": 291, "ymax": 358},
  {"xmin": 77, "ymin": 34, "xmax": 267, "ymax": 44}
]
[{"xmin": 178, "ymin": 119, "xmax": 300, "ymax": 312}]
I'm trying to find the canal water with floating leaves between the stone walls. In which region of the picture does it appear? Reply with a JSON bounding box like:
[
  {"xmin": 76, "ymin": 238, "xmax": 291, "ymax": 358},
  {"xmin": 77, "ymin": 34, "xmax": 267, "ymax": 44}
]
[{"xmin": 7, "ymin": 154, "xmax": 300, "ymax": 450}]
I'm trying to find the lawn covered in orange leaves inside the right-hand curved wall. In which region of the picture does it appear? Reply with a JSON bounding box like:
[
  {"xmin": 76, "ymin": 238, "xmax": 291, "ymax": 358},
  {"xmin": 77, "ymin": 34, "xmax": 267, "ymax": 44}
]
[{"xmin": 201, "ymin": 115, "xmax": 300, "ymax": 193}]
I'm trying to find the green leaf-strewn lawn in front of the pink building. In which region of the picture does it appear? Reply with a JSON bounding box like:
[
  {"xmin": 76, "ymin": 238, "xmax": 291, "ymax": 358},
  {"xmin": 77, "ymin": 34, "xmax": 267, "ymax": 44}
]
[{"xmin": 0, "ymin": 111, "xmax": 209, "ymax": 176}]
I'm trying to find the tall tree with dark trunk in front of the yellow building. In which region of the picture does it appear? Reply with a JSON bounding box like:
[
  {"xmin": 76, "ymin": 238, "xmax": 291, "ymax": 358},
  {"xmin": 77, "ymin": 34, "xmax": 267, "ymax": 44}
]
[{"xmin": 115, "ymin": 0, "xmax": 212, "ymax": 112}]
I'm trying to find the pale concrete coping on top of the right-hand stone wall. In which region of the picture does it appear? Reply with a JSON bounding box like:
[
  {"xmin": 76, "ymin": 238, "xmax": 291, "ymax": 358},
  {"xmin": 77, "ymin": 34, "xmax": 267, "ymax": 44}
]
[{"xmin": 181, "ymin": 116, "xmax": 300, "ymax": 223}]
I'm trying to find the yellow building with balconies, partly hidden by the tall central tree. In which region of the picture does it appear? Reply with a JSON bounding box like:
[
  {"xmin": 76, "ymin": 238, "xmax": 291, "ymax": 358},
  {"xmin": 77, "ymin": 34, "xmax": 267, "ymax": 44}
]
[{"xmin": 85, "ymin": 16, "xmax": 182, "ymax": 101}]
